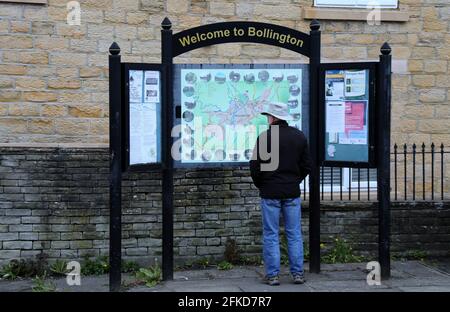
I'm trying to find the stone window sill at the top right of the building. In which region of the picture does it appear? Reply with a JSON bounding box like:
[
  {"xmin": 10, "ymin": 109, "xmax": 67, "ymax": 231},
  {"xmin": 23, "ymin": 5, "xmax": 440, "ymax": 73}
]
[{"xmin": 303, "ymin": 8, "xmax": 409, "ymax": 22}]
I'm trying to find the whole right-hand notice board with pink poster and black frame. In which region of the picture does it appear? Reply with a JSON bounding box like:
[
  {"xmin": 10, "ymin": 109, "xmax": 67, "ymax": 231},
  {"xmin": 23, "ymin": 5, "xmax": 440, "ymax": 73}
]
[{"xmin": 319, "ymin": 63, "xmax": 376, "ymax": 167}]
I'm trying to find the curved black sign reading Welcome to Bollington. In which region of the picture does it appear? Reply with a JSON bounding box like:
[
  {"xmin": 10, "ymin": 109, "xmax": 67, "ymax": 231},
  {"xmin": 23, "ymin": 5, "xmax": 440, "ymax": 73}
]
[{"xmin": 172, "ymin": 22, "xmax": 310, "ymax": 56}]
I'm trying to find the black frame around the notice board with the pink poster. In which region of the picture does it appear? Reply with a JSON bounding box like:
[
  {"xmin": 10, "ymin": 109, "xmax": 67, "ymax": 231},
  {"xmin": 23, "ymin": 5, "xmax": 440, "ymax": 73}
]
[{"xmin": 318, "ymin": 62, "xmax": 378, "ymax": 168}]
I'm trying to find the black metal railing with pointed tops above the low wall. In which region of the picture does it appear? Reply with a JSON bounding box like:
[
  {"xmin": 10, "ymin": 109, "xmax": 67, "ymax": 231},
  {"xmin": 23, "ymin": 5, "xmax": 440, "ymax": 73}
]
[{"xmin": 302, "ymin": 143, "xmax": 450, "ymax": 201}]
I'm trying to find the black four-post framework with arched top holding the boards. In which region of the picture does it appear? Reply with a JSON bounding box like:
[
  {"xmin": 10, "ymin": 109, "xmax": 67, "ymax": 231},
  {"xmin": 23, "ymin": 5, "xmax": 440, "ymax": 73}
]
[{"xmin": 108, "ymin": 17, "xmax": 392, "ymax": 291}]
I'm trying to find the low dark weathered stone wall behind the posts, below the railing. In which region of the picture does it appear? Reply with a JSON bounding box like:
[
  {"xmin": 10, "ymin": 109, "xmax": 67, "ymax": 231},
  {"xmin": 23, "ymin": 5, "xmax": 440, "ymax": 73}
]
[{"xmin": 0, "ymin": 147, "xmax": 450, "ymax": 264}]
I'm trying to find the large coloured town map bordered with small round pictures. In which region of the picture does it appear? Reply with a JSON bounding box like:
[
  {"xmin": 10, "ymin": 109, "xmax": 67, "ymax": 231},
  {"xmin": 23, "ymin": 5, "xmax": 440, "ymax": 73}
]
[{"xmin": 180, "ymin": 68, "xmax": 302, "ymax": 163}]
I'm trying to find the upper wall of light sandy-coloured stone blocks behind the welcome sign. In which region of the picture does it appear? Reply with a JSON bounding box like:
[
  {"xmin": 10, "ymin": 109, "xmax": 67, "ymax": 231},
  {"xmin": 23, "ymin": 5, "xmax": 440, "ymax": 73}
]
[{"xmin": 0, "ymin": 0, "xmax": 450, "ymax": 145}]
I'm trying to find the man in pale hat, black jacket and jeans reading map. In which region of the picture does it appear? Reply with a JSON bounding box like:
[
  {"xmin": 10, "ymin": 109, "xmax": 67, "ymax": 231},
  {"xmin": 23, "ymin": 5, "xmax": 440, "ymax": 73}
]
[{"xmin": 250, "ymin": 103, "xmax": 311, "ymax": 286}]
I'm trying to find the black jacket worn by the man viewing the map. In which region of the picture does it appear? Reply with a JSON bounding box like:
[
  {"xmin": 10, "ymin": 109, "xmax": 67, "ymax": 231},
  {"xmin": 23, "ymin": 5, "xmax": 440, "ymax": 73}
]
[{"xmin": 250, "ymin": 120, "xmax": 311, "ymax": 199}]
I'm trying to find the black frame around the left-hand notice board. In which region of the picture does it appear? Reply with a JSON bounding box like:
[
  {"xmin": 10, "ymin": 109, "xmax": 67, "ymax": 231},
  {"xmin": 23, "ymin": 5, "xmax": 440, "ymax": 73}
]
[{"xmin": 121, "ymin": 63, "xmax": 165, "ymax": 172}]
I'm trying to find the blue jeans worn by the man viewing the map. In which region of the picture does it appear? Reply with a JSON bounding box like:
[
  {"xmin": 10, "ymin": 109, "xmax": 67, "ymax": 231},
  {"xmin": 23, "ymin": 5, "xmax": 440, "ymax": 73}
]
[{"xmin": 261, "ymin": 198, "xmax": 303, "ymax": 277}]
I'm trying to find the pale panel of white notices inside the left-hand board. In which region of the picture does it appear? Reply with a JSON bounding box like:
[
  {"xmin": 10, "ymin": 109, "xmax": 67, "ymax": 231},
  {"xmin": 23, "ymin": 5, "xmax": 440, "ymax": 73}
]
[{"xmin": 129, "ymin": 70, "xmax": 160, "ymax": 165}]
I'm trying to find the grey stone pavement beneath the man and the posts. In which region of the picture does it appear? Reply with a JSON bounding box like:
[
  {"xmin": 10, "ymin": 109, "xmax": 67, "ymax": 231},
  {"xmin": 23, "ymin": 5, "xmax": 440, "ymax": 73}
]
[{"xmin": 0, "ymin": 261, "xmax": 450, "ymax": 292}]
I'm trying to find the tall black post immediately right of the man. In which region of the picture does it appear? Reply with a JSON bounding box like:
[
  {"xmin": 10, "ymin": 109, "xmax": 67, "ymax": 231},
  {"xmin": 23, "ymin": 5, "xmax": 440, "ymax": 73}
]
[{"xmin": 309, "ymin": 20, "xmax": 320, "ymax": 273}]
